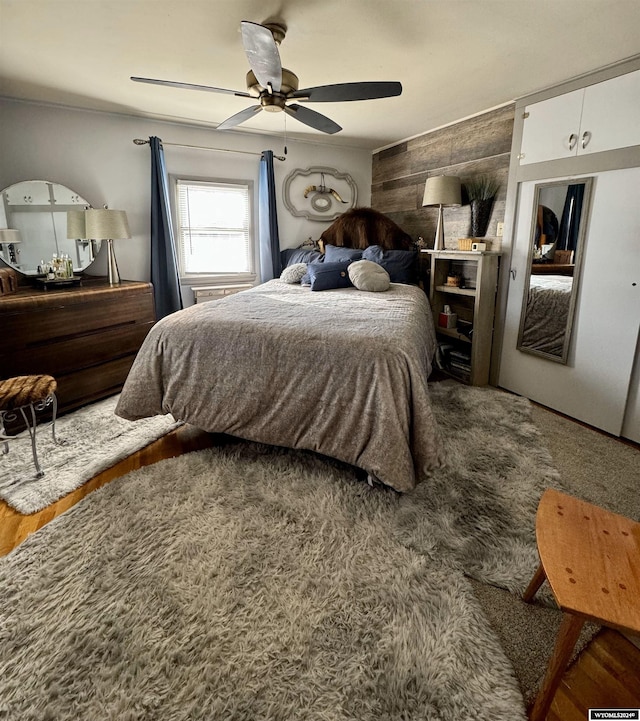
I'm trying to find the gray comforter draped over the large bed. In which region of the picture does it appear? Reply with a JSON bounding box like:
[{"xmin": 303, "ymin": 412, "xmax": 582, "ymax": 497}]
[{"xmin": 116, "ymin": 280, "xmax": 438, "ymax": 491}]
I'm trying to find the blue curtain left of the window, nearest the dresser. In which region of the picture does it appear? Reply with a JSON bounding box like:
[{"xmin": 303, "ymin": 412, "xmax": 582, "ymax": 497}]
[{"xmin": 149, "ymin": 136, "xmax": 182, "ymax": 320}]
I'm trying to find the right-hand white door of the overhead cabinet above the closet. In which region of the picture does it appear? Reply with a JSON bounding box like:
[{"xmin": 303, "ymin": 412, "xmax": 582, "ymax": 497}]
[{"xmin": 578, "ymin": 70, "xmax": 640, "ymax": 155}]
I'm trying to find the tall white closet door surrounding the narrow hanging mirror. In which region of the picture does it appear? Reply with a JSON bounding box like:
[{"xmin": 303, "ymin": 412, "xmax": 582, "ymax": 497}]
[{"xmin": 499, "ymin": 168, "xmax": 640, "ymax": 435}]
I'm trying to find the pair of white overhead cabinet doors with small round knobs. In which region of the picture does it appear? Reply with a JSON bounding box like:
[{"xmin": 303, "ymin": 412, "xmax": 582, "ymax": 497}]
[{"xmin": 519, "ymin": 70, "xmax": 640, "ymax": 165}]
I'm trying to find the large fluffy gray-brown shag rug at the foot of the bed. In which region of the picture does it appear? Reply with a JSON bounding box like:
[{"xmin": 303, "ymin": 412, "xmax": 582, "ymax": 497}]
[{"xmin": 0, "ymin": 383, "xmax": 604, "ymax": 721}]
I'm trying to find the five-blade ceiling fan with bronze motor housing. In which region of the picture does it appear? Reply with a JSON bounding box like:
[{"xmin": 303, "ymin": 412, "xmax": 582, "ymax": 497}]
[{"xmin": 131, "ymin": 20, "xmax": 402, "ymax": 134}]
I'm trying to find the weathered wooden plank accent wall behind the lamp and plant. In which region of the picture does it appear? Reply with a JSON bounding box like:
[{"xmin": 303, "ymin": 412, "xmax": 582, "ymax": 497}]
[{"xmin": 371, "ymin": 105, "xmax": 515, "ymax": 250}]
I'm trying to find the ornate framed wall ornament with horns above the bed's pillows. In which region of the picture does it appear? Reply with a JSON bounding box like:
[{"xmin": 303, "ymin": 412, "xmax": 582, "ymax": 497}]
[{"xmin": 283, "ymin": 166, "xmax": 358, "ymax": 222}]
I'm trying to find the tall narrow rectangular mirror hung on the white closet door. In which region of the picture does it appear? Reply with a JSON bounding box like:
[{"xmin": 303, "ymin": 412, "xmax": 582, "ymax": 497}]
[{"xmin": 517, "ymin": 178, "xmax": 593, "ymax": 364}]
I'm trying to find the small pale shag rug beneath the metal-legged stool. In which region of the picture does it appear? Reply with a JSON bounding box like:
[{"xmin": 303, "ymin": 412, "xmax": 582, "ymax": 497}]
[{"xmin": 0, "ymin": 396, "xmax": 180, "ymax": 514}]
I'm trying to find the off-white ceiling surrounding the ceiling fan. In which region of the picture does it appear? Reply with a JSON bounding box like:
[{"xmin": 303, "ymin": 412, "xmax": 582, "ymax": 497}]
[{"xmin": 0, "ymin": 0, "xmax": 640, "ymax": 149}]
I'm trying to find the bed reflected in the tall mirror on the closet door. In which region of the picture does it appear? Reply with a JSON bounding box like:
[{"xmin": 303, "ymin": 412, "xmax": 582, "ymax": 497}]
[{"xmin": 521, "ymin": 275, "xmax": 573, "ymax": 356}]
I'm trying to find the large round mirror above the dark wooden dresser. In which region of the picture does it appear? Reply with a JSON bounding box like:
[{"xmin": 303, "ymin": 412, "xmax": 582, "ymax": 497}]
[{"xmin": 0, "ymin": 180, "xmax": 100, "ymax": 276}]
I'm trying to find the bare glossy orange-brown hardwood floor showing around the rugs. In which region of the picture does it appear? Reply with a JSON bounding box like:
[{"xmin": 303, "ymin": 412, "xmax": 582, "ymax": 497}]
[{"xmin": 0, "ymin": 426, "xmax": 640, "ymax": 721}]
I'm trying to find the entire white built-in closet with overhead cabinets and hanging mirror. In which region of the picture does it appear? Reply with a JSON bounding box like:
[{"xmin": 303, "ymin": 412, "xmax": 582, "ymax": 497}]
[{"xmin": 498, "ymin": 63, "xmax": 640, "ymax": 443}]
